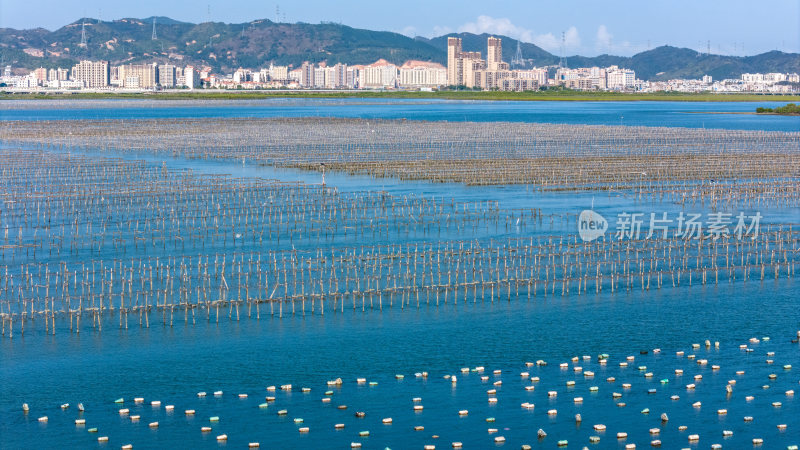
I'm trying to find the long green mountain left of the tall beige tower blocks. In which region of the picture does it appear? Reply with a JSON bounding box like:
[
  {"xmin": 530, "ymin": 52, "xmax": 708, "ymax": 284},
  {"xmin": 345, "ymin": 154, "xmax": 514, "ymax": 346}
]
[{"xmin": 0, "ymin": 17, "xmax": 444, "ymax": 71}]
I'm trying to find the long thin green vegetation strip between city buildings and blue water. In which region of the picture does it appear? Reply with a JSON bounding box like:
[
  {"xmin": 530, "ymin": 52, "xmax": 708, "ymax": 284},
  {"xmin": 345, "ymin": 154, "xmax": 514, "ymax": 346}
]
[{"xmin": 0, "ymin": 90, "xmax": 800, "ymax": 102}]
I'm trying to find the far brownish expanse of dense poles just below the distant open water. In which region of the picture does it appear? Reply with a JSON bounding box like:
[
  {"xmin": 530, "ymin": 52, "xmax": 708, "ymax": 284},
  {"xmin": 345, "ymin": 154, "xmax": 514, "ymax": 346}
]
[{"xmin": 0, "ymin": 118, "xmax": 800, "ymax": 192}]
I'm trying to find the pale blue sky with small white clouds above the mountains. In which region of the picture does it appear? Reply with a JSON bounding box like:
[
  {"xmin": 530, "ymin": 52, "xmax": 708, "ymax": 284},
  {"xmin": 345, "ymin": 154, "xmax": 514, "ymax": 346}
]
[{"xmin": 0, "ymin": 0, "xmax": 800, "ymax": 59}]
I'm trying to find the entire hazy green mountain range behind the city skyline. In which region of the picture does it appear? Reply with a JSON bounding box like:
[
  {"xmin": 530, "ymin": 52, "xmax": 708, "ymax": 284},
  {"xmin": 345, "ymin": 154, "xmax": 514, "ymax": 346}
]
[{"xmin": 0, "ymin": 17, "xmax": 800, "ymax": 80}]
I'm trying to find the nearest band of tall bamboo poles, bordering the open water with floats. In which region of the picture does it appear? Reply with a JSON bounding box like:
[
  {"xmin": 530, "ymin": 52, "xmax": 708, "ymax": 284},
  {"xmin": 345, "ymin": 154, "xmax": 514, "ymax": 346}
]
[{"xmin": 0, "ymin": 224, "xmax": 800, "ymax": 336}]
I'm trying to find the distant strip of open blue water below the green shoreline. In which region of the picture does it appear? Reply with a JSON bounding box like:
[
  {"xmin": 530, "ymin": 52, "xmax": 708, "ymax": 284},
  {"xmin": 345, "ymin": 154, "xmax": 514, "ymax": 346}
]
[{"xmin": 0, "ymin": 99, "xmax": 800, "ymax": 131}]
